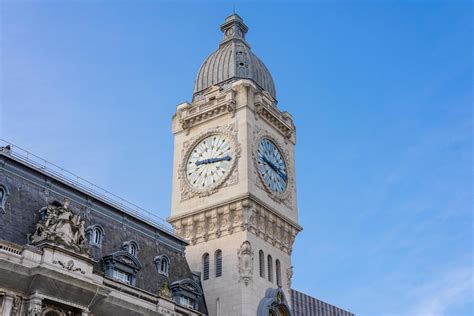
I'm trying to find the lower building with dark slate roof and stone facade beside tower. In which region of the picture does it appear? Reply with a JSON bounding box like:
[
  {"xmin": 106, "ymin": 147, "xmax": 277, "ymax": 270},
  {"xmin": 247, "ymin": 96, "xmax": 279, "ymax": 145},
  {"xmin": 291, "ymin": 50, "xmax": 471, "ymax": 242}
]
[{"xmin": 0, "ymin": 147, "xmax": 207, "ymax": 315}]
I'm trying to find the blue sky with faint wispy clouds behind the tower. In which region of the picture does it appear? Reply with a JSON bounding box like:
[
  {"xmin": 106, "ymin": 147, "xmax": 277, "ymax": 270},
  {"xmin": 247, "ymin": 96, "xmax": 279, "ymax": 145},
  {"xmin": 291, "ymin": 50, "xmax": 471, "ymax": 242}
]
[{"xmin": 0, "ymin": 0, "xmax": 473, "ymax": 316}]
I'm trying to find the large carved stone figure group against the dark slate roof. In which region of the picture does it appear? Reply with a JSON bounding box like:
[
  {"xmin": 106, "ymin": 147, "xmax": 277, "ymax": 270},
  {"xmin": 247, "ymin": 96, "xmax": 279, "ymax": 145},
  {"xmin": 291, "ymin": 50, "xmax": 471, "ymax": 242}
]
[{"xmin": 31, "ymin": 199, "xmax": 88, "ymax": 253}]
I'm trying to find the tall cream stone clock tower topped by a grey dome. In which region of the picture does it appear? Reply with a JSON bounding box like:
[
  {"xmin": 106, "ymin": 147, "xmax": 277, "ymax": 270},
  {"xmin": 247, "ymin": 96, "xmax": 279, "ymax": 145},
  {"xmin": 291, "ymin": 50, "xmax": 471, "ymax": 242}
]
[{"xmin": 169, "ymin": 14, "xmax": 301, "ymax": 316}]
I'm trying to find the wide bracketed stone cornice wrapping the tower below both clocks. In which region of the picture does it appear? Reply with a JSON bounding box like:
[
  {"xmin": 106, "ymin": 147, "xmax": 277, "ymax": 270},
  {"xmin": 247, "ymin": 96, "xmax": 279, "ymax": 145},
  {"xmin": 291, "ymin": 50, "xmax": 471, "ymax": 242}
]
[{"xmin": 169, "ymin": 197, "xmax": 301, "ymax": 254}]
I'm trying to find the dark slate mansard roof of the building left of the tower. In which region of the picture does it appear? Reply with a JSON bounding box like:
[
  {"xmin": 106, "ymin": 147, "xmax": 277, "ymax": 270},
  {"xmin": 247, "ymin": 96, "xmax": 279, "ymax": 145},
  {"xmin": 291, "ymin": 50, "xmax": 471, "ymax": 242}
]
[{"xmin": 0, "ymin": 152, "xmax": 206, "ymax": 312}]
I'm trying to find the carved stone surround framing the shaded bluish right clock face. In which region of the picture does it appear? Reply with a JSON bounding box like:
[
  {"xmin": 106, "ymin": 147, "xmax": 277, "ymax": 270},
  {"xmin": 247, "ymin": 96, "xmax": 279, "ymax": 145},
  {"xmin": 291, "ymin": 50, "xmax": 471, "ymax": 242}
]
[{"xmin": 252, "ymin": 127, "xmax": 294, "ymax": 207}]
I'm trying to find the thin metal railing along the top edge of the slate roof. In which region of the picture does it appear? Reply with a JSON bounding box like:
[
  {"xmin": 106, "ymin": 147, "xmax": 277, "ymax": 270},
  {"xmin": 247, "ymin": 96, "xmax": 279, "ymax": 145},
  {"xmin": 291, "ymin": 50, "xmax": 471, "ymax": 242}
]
[{"xmin": 0, "ymin": 139, "xmax": 174, "ymax": 234}]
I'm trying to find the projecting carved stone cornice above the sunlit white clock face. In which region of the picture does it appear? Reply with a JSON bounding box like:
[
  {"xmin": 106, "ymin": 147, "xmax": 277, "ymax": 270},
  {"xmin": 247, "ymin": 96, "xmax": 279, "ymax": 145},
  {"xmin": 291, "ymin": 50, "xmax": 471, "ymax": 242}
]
[{"xmin": 177, "ymin": 86, "xmax": 236, "ymax": 134}]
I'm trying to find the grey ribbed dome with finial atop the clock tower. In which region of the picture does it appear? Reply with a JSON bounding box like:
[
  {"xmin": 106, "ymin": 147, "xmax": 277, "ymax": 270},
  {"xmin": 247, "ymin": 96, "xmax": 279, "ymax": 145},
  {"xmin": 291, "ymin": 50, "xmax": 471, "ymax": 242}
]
[{"xmin": 194, "ymin": 14, "xmax": 276, "ymax": 99}]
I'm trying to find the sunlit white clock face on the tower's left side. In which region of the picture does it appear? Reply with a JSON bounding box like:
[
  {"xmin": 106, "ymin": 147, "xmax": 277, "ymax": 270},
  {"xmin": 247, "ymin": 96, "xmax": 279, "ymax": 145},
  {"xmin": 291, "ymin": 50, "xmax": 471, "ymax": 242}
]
[{"xmin": 186, "ymin": 134, "xmax": 234, "ymax": 190}]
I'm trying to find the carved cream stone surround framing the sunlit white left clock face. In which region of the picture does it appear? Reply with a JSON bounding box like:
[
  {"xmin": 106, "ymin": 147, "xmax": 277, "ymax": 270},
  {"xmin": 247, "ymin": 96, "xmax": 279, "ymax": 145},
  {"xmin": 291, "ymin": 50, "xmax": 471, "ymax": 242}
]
[{"xmin": 178, "ymin": 124, "xmax": 240, "ymax": 201}]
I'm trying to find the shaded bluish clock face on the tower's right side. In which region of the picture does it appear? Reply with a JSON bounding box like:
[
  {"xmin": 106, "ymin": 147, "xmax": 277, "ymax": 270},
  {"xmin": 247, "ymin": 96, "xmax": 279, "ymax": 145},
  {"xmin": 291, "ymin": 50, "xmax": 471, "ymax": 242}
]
[{"xmin": 257, "ymin": 138, "xmax": 288, "ymax": 193}]
